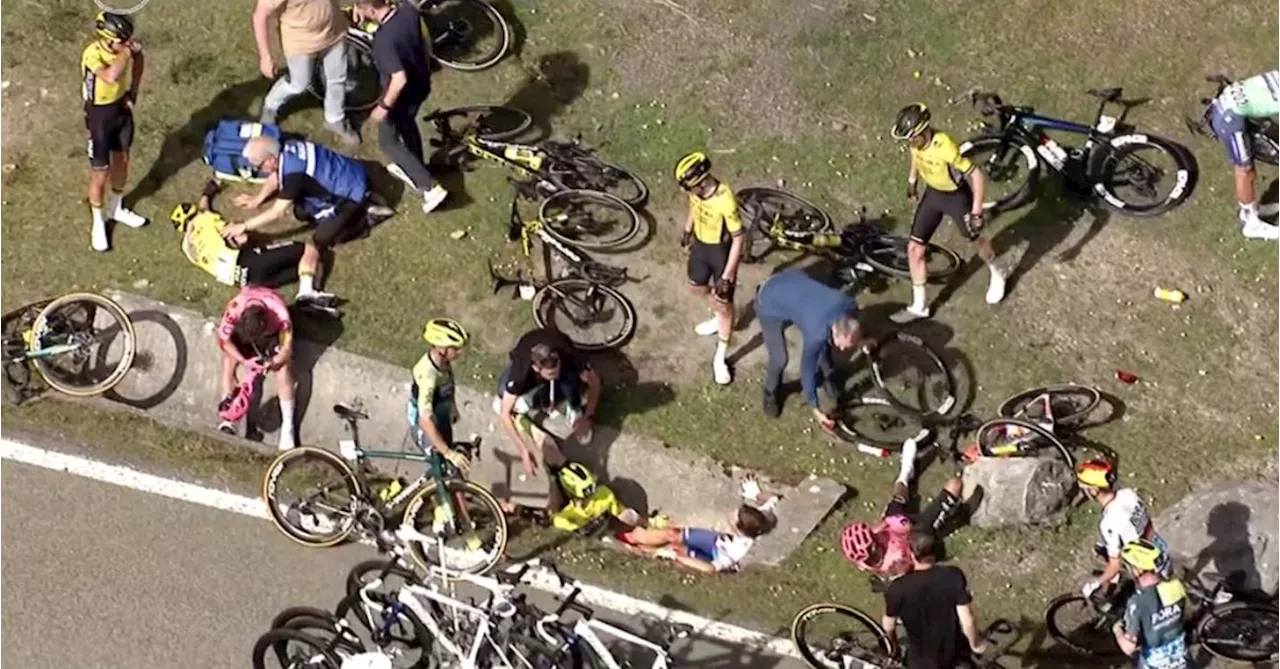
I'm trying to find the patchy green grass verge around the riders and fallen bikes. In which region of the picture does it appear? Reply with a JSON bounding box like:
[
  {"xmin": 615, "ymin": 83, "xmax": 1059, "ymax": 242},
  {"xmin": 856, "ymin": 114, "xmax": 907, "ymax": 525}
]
[{"xmin": 0, "ymin": 0, "xmax": 1280, "ymax": 654}]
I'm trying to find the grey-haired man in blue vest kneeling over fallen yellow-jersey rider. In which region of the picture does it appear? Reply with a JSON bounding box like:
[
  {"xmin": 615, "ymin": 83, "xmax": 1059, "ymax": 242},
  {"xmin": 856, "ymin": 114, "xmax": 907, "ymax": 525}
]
[{"xmin": 223, "ymin": 137, "xmax": 392, "ymax": 249}]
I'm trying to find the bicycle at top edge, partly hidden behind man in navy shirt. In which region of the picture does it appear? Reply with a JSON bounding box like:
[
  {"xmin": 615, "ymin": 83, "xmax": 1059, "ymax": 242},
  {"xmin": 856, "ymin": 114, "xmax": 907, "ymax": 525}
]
[{"xmin": 307, "ymin": 0, "xmax": 511, "ymax": 111}]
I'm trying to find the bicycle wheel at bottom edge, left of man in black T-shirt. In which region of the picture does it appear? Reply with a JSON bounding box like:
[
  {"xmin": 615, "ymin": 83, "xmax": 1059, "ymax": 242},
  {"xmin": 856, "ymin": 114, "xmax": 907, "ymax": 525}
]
[{"xmin": 791, "ymin": 604, "xmax": 897, "ymax": 669}]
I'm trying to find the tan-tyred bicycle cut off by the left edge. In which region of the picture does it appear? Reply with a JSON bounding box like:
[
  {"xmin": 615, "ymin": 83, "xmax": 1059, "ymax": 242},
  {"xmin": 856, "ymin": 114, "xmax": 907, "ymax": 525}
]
[{"xmin": 0, "ymin": 293, "xmax": 137, "ymax": 404}]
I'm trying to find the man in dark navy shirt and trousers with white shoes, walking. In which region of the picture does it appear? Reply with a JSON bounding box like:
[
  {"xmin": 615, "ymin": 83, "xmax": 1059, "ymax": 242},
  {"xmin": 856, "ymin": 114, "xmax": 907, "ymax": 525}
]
[{"xmin": 355, "ymin": 0, "xmax": 449, "ymax": 214}]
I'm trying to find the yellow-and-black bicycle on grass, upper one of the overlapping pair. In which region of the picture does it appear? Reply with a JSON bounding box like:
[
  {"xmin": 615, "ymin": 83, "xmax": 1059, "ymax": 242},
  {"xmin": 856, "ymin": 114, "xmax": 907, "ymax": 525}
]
[{"xmin": 425, "ymin": 105, "xmax": 649, "ymax": 207}]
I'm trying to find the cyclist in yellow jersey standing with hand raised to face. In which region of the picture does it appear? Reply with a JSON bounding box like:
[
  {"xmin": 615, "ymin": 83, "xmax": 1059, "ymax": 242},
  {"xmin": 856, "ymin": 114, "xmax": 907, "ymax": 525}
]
[{"xmin": 81, "ymin": 12, "xmax": 147, "ymax": 251}]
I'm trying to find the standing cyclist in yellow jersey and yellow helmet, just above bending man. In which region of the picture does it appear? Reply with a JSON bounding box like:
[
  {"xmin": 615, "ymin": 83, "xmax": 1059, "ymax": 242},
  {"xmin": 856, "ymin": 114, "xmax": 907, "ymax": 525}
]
[{"xmin": 676, "ymin": 151, "xmax": 746, "ymax": 385}]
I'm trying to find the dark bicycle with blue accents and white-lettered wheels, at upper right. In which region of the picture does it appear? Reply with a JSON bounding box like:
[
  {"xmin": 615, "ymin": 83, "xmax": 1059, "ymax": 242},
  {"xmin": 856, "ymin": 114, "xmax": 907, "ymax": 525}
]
[{"xmin": 960, "ymin": 88, "xmax": 1192, "ymax": 217}]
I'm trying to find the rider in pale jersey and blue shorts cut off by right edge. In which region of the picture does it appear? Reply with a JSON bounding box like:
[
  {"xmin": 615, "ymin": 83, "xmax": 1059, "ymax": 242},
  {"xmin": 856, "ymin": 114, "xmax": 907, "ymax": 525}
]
[{"xmin": 1208, "ymin": 70, "xmax": 1280, "ymax": 239}]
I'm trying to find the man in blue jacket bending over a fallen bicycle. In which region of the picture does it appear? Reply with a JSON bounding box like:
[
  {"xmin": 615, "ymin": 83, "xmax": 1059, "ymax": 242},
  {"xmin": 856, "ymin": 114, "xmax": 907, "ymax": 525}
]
[{"xmin": 755, "ymin": 270, "xmax": 863, "ymax": 431}]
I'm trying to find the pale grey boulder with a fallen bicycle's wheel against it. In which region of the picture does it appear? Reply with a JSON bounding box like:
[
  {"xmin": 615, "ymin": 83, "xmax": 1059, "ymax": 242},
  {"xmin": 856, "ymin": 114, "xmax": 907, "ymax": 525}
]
[{"xmin": 964, "ymin": 458, "xmax": 1075, "ymax": 527}]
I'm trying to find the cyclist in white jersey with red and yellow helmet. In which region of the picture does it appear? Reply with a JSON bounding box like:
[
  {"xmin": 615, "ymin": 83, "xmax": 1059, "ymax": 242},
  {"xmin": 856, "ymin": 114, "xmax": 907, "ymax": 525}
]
[{"xmin": 1075, "ymin": 459, "xmax": 1171, "ymax": 599}]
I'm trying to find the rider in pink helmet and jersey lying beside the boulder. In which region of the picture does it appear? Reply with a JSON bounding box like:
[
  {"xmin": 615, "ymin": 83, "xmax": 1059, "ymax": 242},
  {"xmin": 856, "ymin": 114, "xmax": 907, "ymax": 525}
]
[{"xmin": 840, "ymin": 439, "xmax": 964, "ymax": 579}]
